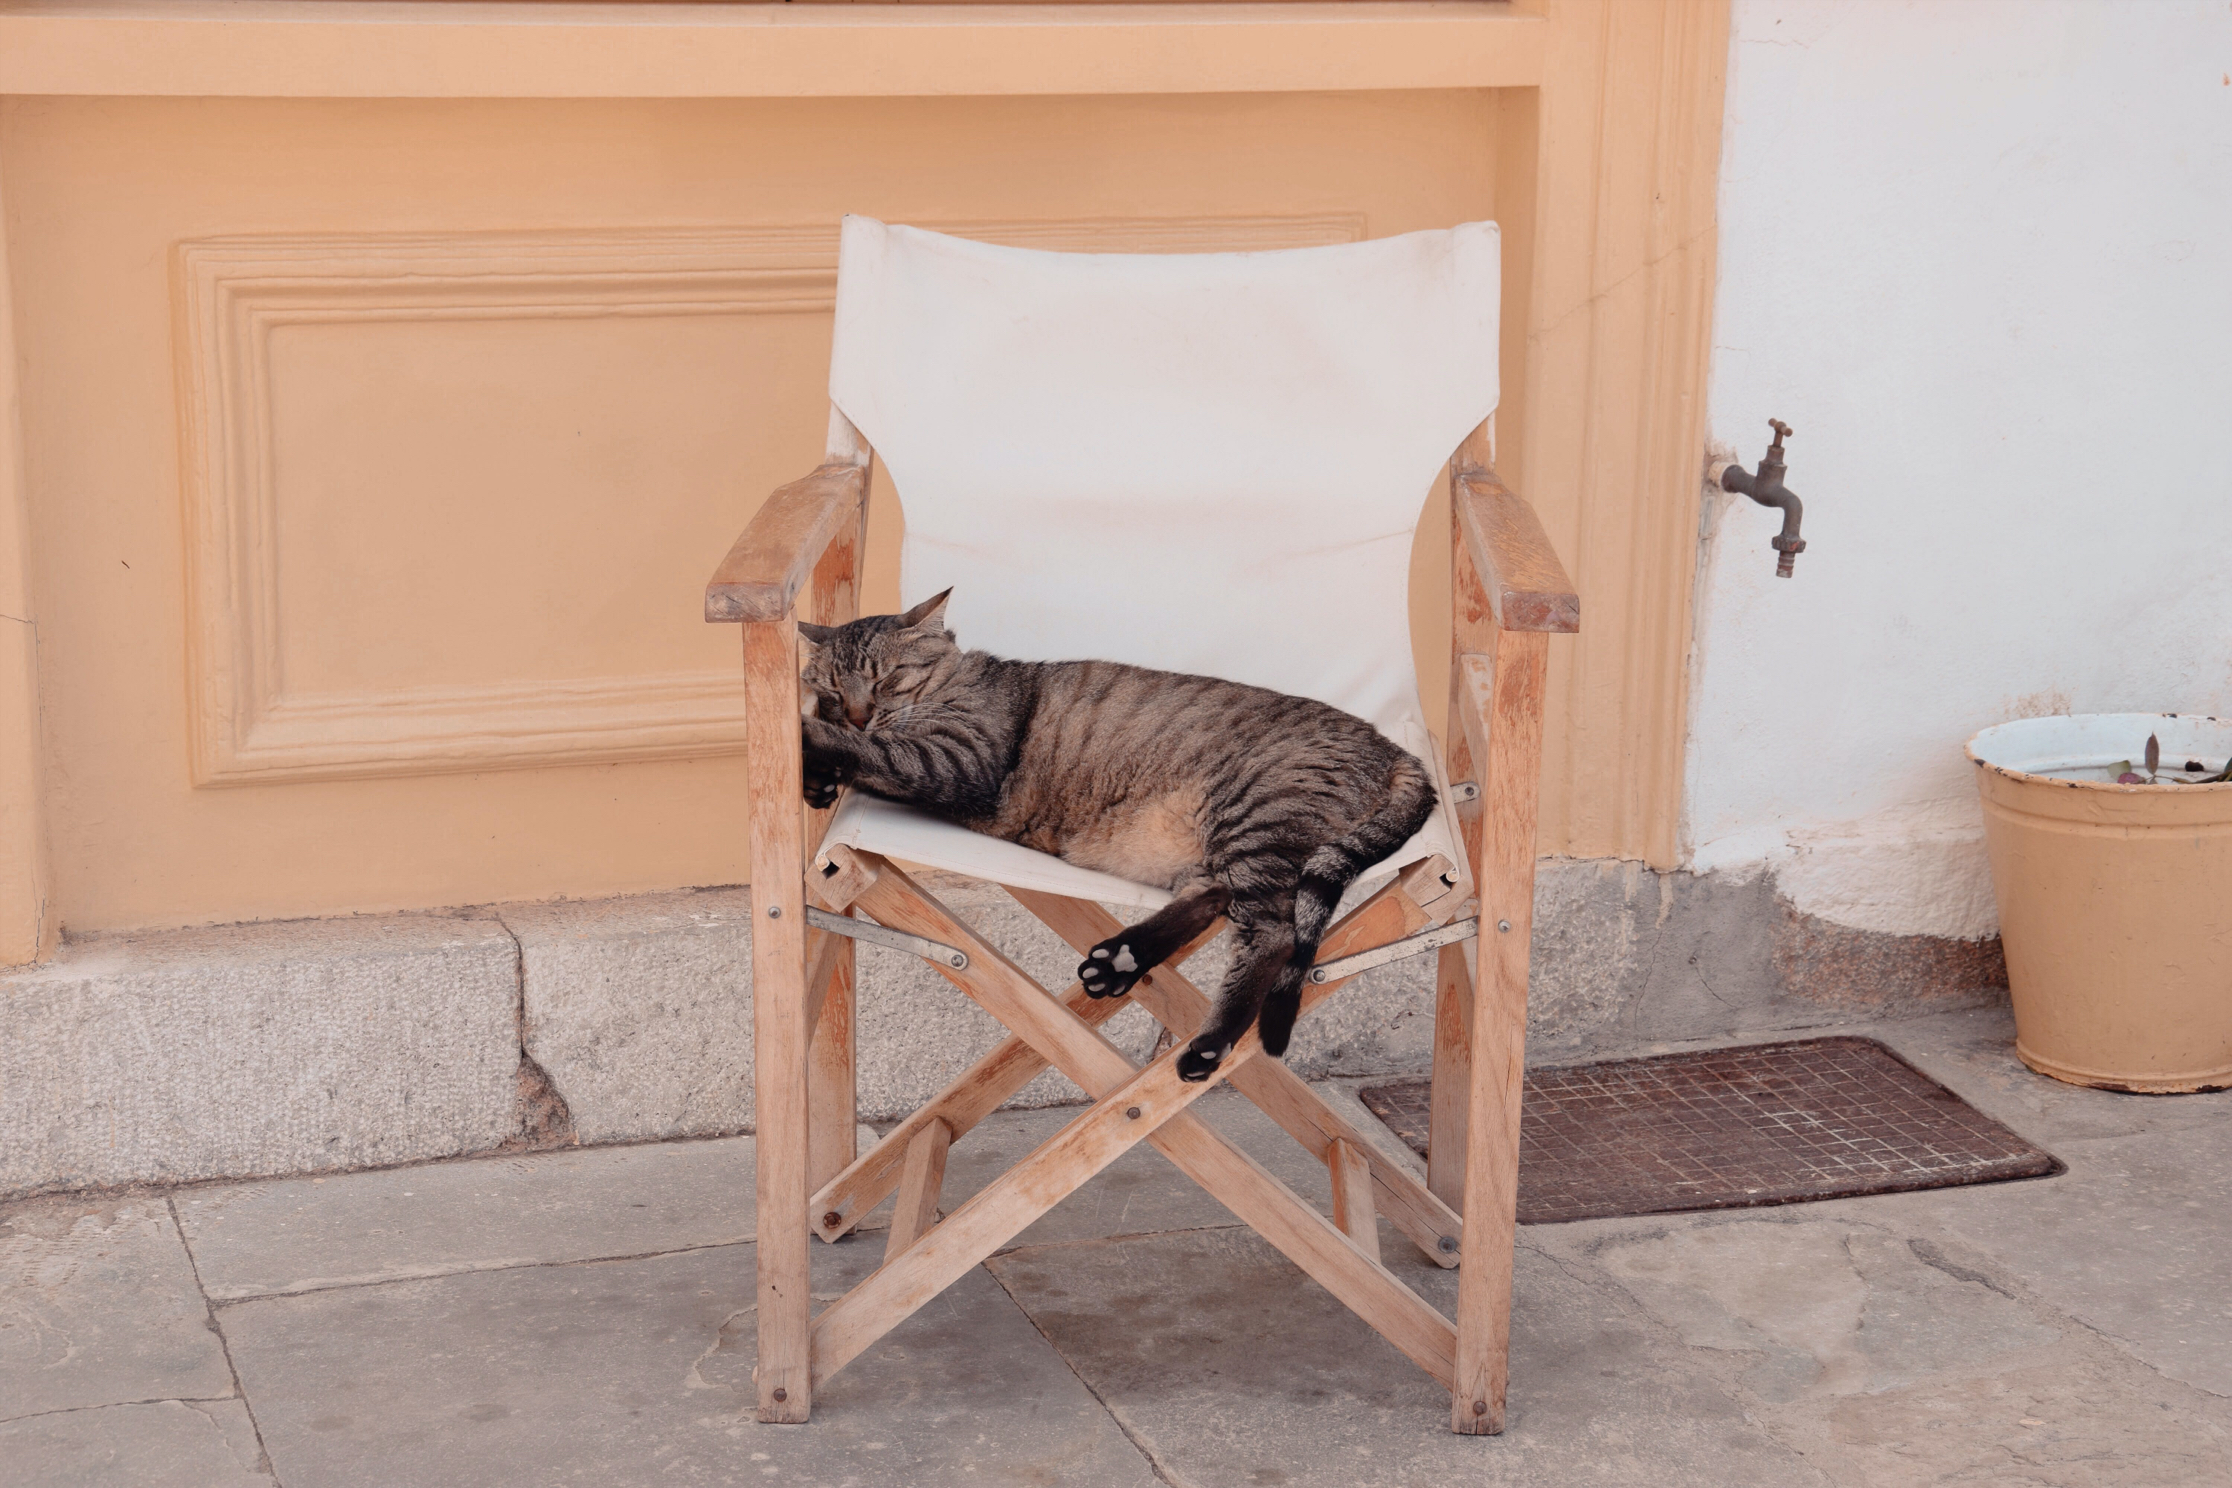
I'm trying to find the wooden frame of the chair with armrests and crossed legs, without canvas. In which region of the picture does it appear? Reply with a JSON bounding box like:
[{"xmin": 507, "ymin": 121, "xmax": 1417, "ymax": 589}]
[{"xmin": 705, "ymin": 406, "xmax": 1580, "ymax": 1434}]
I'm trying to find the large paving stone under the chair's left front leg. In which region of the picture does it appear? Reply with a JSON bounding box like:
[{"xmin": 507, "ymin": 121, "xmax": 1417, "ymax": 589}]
[{"xmin": 221, "ymin": 1240, "xmax": 1154, "ymax": 1488}]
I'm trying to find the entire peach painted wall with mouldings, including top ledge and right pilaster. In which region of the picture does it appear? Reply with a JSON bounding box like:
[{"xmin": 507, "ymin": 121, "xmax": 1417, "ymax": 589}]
[{"xmin": 0, "ymin": 0, "xmax": 1725, "ymax": 964}]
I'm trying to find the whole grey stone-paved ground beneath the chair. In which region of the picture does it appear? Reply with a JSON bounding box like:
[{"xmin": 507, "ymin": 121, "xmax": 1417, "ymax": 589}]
[{"xmin": 0, "ymin": 1013, "xmax": 2232, "ymax": 1488}]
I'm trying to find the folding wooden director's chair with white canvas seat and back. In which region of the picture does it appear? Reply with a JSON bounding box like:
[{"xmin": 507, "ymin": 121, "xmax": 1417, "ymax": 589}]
[{"xmin": 705, "ymin": 219, "xmax": 1580, "ymax": 1434}]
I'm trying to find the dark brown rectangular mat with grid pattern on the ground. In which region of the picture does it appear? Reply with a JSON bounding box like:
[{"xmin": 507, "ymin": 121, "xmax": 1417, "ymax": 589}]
[{"xmin": 1359, "ymin": 1037, "xmax": 2062, "ymax": 1225}]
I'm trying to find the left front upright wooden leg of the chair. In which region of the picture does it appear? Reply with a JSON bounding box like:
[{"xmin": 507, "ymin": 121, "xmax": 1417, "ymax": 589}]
[{"xmin": 743, "ymin": 616, "xmax": 812, "ymax": 1421}]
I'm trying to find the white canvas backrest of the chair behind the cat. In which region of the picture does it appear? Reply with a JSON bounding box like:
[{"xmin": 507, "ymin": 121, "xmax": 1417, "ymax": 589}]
[{"xmin": 830, "ymin": 216, "xmax": 1498, "ymax": 738}]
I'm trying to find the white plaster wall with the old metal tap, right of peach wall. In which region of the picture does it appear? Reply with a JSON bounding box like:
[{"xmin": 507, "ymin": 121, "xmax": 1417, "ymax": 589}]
[{"xmin": 1683, "ymin": 0, "xmax": 2232, "ymax": 937}]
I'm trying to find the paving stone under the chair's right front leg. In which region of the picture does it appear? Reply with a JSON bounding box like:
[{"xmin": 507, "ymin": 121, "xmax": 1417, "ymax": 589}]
[{"xmin": 991, "ymin": 1229, "xmax": 1826, "ymax": 1488}]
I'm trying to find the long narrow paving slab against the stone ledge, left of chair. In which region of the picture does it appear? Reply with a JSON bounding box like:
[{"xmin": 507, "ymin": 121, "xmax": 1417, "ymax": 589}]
[{"xmin": 176, "ymin": 1127, "xmax": 884, "ymax": 1301}]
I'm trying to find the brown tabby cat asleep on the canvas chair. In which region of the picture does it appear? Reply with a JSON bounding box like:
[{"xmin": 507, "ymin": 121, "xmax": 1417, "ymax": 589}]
[{"xmin": 799, "ymin": 589, "xmax": 1433, "ymax": 1080}]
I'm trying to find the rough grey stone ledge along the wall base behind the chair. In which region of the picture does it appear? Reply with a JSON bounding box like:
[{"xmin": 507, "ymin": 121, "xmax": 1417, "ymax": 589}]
[{"xmin": 0, "ymin": 861, "xmax": 2004, "ymax": 1198}]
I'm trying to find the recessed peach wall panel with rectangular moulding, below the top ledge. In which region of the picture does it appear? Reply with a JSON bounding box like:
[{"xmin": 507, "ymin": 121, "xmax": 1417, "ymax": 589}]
[{"xmin": 0, "ymin": 94, "xmax": 1493, "ymax": 928}]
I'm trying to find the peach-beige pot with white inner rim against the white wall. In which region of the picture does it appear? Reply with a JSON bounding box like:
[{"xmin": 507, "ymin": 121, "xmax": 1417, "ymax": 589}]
[{"xmin": 1969, "ymin": 714, "xmax": 2232, "ymax": 1091}]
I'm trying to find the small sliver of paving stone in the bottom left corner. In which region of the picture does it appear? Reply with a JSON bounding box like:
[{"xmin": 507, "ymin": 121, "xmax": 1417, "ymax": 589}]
[{"xmin": 0, "ymin": 1401, "xmax": 267, "ymax": 1488}]
